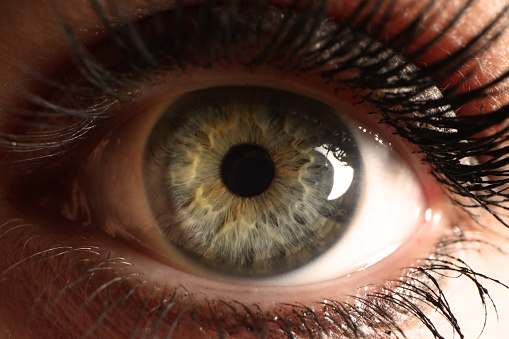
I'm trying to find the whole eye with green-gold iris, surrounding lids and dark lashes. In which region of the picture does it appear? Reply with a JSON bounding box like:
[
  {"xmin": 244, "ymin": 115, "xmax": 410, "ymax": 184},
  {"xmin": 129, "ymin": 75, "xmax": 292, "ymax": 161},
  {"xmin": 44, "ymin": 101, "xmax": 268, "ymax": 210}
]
[{"xmin": 0, "ymin": 1, "xmax": 508, "ymax": 336}]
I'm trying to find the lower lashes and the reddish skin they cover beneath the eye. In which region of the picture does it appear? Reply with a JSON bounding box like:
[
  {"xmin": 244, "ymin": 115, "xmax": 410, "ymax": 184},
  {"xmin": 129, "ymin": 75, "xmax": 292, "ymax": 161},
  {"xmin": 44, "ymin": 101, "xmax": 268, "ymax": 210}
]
[{"xmin": 0, "ymin": 215, "xmax": 509, "ymax": 338}]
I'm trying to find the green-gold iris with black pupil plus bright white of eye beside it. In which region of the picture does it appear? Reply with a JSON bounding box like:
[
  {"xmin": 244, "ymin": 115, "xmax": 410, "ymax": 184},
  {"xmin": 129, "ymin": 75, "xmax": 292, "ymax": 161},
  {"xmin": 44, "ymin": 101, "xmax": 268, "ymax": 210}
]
[{"xmin": 110, "ymin": 86, "xmax": 440, "ymax": 285}]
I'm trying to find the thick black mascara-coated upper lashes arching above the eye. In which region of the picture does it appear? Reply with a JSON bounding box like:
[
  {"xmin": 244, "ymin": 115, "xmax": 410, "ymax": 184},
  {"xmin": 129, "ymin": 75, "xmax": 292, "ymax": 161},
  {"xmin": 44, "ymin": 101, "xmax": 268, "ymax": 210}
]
[{"xmin": 14, "ymin": 0, "xmax": 509, "ymax": 226}]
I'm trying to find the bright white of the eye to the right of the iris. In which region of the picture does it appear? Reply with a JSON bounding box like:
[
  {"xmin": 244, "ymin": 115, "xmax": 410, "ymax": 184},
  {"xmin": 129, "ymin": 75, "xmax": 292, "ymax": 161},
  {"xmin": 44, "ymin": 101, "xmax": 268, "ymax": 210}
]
[{"xmin": 239, "ymin": 129, "xmax": 437, "ymax": 285}]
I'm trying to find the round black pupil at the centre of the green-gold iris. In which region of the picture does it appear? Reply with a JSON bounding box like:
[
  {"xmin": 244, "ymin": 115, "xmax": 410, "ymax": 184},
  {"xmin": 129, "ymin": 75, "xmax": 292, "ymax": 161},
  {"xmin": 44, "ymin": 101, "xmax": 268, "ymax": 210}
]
[{"xmin": 221, "ymin": 144, "xmax": 274, "ymax": 197}]
